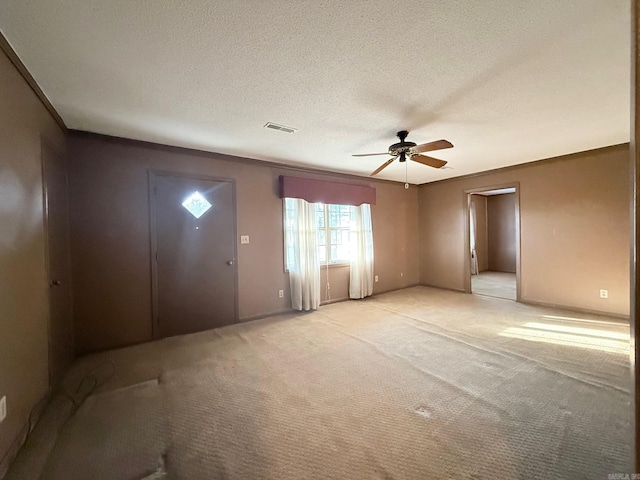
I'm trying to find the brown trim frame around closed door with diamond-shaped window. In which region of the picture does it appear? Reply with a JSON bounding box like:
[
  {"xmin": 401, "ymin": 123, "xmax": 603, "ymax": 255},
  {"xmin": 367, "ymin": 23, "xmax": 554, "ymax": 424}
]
[{"xmin": 147, "ymin": 169, "xmax": 239, "ymax": 340}]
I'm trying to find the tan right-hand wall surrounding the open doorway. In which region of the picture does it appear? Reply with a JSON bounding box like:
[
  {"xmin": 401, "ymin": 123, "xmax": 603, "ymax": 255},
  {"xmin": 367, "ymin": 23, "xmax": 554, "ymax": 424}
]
[{"xmin": 419, "ymin": 145, "xmax": 630, "ymax": 315}]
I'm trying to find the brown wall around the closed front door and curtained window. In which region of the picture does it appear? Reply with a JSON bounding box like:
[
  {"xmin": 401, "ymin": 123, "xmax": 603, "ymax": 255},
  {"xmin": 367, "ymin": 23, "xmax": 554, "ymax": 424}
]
[{"xmin": 69, "ymin": 133, "xmax": 419, "ymax": 352}]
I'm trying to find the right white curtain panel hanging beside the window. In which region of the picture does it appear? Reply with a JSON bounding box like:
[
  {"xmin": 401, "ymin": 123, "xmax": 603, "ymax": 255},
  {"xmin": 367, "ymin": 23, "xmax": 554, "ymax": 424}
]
[{"xmin": 349, "ymin": 203, "xmax": 373, "ymax": 298}]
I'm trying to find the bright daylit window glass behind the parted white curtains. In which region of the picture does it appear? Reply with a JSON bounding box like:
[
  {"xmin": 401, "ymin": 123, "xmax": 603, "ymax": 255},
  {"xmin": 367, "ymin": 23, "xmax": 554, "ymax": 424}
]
[{"xmin": 284, "ymin": 198, "xmax": 351, "ymax": 269}]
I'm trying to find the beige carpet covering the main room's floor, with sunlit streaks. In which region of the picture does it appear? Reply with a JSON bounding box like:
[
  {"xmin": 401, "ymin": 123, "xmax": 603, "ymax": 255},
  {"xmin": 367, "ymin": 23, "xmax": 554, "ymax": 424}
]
[{"xmin": 7, "ymin": 287, "xmax": 631, "ymax": 480}]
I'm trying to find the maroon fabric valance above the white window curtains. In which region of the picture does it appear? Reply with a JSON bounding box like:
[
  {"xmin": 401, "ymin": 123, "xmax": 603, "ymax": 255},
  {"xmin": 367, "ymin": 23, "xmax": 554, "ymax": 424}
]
[{"xmin": 280, "ymin": 175, "xmax": 376, "ymax": 205}]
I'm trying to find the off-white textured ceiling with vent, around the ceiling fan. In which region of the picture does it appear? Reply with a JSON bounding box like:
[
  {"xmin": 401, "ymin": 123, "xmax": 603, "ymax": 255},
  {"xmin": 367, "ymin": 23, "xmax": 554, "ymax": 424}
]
[{"xmin": 0, "ymin": 0, "xmax": 630, "ymax": 184}]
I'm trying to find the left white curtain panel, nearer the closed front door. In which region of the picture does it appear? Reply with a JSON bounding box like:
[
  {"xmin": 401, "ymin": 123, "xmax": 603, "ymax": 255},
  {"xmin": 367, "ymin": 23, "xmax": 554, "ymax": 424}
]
[{"xmin": 285, "ymin": 198, "xmax": 320, "ymax": 310}]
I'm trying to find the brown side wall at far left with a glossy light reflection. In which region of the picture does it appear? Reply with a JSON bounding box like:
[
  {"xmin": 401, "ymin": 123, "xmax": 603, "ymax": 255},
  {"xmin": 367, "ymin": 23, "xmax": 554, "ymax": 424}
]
[{"xmin": 0, "ymin": 51, "xmax": 64, "ymax": 476}]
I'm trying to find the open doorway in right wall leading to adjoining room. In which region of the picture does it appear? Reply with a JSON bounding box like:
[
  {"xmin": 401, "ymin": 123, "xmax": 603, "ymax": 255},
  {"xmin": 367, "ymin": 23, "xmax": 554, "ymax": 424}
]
[{"xmin": 465, "ymin": 183, "xmax": 520, "ymax": 301}]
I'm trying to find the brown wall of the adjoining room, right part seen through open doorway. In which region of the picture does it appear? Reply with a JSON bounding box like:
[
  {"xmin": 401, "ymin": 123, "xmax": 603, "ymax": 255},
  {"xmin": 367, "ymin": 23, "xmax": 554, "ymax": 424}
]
[{"xmin": 487, "ymin": 193, "xmax": 516, "ymax": 273}]
